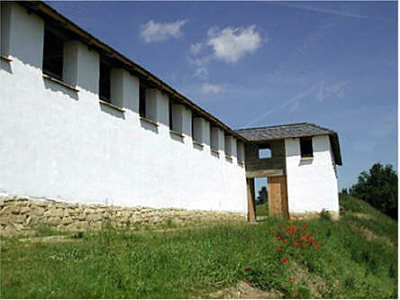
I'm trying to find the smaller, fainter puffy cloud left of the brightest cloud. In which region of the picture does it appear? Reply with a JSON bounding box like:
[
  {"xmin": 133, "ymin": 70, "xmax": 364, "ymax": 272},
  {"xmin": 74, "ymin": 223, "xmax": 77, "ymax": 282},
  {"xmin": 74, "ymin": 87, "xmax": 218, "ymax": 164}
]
[{"xmin": 140, "ymin": 20, "xmax": 187, "ymax": 43}]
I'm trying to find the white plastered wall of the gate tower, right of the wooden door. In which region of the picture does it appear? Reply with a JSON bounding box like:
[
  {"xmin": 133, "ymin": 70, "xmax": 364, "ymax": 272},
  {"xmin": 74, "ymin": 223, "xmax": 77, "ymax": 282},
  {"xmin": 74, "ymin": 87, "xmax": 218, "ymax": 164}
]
[{"xmin": 285, "ymin": 135, "xmax": 339, "ymax": 214}]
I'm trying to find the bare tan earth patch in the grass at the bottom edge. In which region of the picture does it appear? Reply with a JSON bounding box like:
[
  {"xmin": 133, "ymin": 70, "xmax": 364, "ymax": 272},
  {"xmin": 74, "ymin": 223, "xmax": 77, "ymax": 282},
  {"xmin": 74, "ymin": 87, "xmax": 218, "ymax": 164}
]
[{"xmin": 209, "ymin": 281, "xmax": 284, "ymax": 299}]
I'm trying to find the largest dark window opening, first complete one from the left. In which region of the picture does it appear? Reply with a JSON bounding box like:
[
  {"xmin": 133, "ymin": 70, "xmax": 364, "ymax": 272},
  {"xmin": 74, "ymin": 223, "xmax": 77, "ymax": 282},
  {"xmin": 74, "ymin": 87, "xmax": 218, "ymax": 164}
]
[{"xmin": 43, "ymin": 30, "xmax": 64, "ymax": 80}]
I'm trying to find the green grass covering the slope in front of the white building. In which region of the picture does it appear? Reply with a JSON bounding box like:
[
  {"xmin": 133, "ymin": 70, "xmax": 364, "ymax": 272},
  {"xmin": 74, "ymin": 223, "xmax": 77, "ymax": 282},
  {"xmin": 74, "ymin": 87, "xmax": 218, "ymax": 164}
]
[{"xmin": 0, "ymin": 197, "xmax": 398, "ymax": 298}]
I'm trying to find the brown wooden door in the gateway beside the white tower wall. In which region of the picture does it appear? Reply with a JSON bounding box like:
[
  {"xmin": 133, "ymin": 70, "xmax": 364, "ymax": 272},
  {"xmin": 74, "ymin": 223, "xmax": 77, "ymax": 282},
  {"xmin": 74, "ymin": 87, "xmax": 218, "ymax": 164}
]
[{"xmin": 268, "ymin": 176, "xmax": 289, "ymax": 216}]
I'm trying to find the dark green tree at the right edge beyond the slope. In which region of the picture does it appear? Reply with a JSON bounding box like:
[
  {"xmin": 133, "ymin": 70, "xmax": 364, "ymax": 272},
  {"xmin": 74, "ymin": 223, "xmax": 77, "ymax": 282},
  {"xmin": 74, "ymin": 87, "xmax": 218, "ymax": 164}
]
[{"xmin": 349, "ymin": 163, "xmax": 398, "ymax": 220}]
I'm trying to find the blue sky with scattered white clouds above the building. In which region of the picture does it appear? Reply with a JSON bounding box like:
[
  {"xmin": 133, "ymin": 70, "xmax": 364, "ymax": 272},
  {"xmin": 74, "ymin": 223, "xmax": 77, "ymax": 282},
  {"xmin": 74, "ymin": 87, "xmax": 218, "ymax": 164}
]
[{"xmin": 49, "ymin": 2, "xmax": 397, "ymax": 189}]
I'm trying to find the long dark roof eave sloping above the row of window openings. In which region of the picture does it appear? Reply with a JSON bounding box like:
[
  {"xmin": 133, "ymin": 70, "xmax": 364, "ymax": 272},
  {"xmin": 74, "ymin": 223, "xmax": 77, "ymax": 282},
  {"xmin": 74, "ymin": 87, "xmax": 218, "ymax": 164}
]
[{"xmin": 18, "ymin": 1, "xmax": 247, "ymax": 142}]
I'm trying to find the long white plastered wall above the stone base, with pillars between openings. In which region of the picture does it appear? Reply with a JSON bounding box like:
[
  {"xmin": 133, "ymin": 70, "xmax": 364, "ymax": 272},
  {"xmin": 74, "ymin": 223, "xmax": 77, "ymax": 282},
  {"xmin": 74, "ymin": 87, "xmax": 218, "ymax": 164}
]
[{"xmin": 0, "ymin": 4, "xmax": 247, "ymax": 214}]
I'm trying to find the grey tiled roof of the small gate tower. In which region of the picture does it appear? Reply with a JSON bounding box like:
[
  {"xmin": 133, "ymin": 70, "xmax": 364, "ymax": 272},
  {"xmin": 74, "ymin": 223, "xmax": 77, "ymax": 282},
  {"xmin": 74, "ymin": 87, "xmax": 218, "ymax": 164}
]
[{"xmin": 236, "ymin": 123, "xmax": 342, "ymax": 165}]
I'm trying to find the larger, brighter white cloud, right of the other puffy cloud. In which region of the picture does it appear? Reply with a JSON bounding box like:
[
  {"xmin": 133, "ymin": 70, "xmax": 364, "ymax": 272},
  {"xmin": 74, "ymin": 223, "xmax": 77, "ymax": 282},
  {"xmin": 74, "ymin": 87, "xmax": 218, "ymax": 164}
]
[{"xmin": 207, "ymin": 25, "xmax": 262, "ymax": 63}]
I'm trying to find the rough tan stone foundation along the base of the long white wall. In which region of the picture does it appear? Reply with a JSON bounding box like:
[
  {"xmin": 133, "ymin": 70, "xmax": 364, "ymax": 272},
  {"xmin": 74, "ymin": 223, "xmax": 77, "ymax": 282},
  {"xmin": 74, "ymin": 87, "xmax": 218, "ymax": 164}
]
[{"xmin": 0, "ymin": 196, "xmax": 246, "ymax": 236}]
